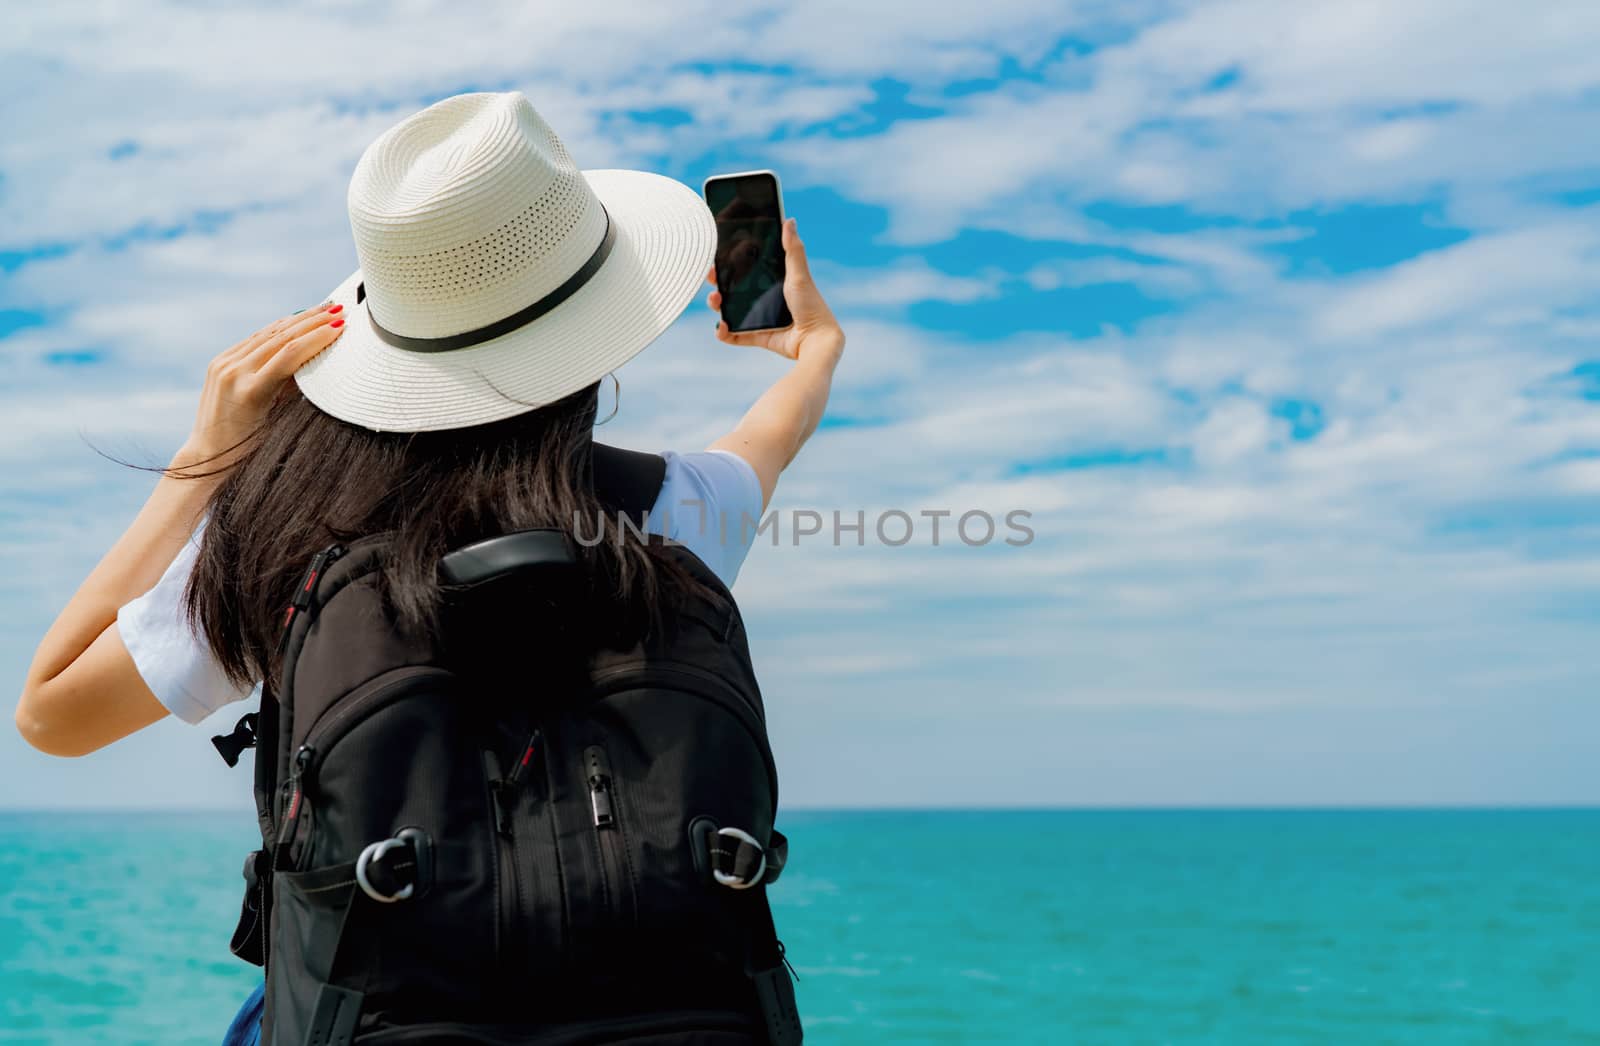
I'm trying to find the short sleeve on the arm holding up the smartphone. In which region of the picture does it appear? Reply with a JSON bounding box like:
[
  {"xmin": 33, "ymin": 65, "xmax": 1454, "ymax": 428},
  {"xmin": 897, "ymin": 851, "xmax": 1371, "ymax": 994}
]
[{"xmin": 650, "ymin": 449, "xmax": 762, "ymax": 589}]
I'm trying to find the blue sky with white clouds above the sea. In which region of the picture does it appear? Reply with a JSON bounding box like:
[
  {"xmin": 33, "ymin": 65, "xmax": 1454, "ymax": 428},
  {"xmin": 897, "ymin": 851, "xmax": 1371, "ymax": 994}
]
[{"xmin": 0, "ymin": 0, "xmax": 1600, "ymax": 809}]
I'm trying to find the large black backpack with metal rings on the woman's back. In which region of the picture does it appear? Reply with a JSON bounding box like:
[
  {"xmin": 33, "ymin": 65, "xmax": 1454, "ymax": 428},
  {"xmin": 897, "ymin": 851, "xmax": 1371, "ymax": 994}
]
[{"xmin": 216, "ymin": 445, "xmax": 802, "ymax": 1046}]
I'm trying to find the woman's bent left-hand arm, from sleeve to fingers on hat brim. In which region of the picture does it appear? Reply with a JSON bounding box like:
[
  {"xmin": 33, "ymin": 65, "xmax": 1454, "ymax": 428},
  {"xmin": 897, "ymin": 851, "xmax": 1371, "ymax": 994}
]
[{"xmin": 16, "ymin": 309, "xmax": 342, "ymax": 755}]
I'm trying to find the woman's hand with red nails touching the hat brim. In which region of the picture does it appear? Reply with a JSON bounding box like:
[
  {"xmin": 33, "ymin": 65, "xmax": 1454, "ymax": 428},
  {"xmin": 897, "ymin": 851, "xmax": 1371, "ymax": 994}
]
[{"xmin": 174, "ymin": 304, "xmax": 344, "ymax": 470}]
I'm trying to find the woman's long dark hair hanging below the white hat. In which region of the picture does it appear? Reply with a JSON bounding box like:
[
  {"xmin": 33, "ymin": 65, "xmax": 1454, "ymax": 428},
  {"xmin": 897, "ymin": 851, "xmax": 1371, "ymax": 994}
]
[{"xmin": 184, "ymin": 384, "xmax": 693, "ymax": 697}]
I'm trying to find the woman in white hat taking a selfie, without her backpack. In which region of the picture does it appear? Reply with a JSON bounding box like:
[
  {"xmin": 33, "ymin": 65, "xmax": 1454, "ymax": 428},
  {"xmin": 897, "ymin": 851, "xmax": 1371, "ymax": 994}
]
[{"xmin": 16, "ymin": 93, "xmax": 845, "ymax": 1041}]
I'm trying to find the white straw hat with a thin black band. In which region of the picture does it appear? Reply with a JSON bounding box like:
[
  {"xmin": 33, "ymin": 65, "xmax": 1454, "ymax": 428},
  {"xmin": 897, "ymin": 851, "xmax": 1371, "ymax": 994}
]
[{"xmin": 294, "ymin": 91, "xmax": 717, "ymax": 432}]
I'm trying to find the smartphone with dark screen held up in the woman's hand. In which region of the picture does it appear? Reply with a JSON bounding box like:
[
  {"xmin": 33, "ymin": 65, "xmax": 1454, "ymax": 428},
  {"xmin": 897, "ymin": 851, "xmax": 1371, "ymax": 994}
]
[{"xmin": 704, "ymin": 171, "xmax": 794, "ymax": 331}]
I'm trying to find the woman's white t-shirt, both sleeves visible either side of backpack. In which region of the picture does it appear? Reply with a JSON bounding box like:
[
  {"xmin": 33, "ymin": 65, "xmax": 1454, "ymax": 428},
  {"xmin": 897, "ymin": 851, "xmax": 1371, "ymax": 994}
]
[{"xmin": 117, "ymin": 451, "xmax": 762, "ymax": 723}]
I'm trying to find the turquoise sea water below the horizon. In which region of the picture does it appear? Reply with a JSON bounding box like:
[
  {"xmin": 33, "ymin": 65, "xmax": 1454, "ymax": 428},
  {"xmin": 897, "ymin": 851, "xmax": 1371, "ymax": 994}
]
[{"xmin": 0, "ymin": 811, "xmax": 1600, "ymax": 1044}]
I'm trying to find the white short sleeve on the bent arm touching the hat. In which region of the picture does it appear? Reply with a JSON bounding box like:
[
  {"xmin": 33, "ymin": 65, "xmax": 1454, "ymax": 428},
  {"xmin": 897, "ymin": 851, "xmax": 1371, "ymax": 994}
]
[{"xmin": 117, "ymin": 531, "xmax": 253, "ymax": 723}]
